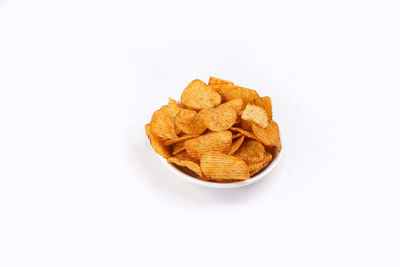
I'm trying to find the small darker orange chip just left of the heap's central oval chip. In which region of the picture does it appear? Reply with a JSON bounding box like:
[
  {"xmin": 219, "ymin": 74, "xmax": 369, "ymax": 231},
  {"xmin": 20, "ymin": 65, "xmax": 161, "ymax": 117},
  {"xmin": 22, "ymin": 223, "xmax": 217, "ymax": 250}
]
[{"xmin": 175, "ymin": 109, "xmax": 207, "ymax": 135}]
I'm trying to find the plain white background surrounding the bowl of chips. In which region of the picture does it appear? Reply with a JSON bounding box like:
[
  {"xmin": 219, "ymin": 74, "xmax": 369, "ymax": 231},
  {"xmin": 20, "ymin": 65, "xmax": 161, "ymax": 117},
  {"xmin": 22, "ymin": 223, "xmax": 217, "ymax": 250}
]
[{"xmin": 0, "ymin": 0, "xmax": 400, "ymax": 267}]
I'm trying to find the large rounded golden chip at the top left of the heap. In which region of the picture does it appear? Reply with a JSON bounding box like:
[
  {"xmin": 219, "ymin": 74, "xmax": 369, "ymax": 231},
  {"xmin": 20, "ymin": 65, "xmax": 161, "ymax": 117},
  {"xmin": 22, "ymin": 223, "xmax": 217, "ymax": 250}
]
[{"xmin": 181, "ymin": 80, "xmax": 221, "ymax": 110}]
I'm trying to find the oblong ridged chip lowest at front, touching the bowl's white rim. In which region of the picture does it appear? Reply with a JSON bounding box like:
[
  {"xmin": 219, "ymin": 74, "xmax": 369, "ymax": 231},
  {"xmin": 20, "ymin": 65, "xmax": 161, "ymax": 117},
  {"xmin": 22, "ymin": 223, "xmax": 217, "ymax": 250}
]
[{"xmin": 200, "ymin": 152, "xmax": 250, "ymax": 180}]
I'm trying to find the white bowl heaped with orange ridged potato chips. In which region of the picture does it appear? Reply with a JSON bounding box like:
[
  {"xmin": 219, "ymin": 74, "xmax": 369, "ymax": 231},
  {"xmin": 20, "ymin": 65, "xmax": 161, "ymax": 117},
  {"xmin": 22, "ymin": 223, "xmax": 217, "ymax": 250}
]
[{"xmin": 145, "ymin": 77, "xmax": 282, "ymax": 188}]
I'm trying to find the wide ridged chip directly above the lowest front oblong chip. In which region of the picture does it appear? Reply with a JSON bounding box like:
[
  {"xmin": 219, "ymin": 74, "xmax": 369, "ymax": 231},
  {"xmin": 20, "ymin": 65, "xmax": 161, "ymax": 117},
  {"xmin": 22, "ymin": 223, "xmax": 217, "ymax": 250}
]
[{"xmin": 185, "ymin": 131, "xmax": 232, "ymax": 159}]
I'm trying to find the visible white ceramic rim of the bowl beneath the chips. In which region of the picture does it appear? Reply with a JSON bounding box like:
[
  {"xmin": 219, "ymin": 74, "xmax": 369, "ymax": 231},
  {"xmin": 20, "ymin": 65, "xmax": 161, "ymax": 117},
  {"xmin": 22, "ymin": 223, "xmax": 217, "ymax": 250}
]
[{"xmin": 158, "ymin": 143, "xmax": 283, "ymax": 188}]
